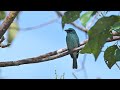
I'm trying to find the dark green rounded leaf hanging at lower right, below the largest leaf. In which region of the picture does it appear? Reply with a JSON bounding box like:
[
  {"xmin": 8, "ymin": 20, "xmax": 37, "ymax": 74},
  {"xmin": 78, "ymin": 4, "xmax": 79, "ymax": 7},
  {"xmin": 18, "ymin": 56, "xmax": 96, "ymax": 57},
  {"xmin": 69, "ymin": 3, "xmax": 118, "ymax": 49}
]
[{"xmin": 104, "ymin": 45, "xmax": 120, "ymax": 69}]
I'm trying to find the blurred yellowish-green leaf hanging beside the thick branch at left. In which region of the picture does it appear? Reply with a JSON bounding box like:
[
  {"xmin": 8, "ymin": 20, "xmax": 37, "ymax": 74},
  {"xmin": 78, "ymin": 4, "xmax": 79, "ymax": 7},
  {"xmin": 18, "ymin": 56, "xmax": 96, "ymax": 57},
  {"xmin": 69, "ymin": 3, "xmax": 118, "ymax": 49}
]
[{"xmin": 7, "ymin": 22, "xmax": 19, "ymax": 43}]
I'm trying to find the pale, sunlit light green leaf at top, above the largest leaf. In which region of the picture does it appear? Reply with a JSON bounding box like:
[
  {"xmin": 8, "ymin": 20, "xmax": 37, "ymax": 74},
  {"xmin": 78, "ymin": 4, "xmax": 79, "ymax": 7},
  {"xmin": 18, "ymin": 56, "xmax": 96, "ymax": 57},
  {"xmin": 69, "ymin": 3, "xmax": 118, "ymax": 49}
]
[{"xmin": 80, "ymin": 11, "xmax": 96, "ymax": 26}]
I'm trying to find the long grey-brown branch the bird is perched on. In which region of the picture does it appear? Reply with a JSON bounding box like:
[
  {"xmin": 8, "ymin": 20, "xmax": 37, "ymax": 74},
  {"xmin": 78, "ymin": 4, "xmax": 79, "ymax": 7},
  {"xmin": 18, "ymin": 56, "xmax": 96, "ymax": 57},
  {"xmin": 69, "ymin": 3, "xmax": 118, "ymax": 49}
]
[{"xmin": 0, "ymin": 36, "xmax": 120, "ymax": 67}]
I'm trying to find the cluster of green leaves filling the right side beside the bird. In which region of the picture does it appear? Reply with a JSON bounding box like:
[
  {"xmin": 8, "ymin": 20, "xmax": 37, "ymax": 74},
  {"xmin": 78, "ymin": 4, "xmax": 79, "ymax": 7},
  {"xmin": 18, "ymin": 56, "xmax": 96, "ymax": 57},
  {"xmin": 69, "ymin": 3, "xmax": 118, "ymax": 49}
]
[{"xmin": 62, "ymin": 11, "xmax": 120, "ymax": 69}]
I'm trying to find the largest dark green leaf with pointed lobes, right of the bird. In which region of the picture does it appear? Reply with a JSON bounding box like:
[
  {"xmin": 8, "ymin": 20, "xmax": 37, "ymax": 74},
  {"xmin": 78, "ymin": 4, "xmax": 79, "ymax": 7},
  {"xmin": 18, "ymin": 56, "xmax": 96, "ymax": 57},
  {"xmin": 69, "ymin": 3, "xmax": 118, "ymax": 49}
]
[{"xmin": 80, "ymin": 15, "xmax": 120, "ymax": 60}]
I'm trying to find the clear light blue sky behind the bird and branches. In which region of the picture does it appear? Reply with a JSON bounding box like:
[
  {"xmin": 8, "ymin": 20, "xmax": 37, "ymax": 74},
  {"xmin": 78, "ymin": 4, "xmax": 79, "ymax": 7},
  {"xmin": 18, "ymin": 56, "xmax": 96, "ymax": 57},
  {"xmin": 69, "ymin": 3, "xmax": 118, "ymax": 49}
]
[{"xmin": 0, "ymin": 11, "xmax": 120, "ymax": 79}]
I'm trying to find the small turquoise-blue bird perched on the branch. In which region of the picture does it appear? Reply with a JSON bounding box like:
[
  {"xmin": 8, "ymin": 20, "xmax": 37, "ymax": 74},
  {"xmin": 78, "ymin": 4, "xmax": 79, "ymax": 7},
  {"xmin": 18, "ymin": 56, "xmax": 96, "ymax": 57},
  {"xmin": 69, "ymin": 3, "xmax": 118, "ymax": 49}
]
[{"xmin": 65, "ymin": 28, "xmax": 80, "ymax": 69}]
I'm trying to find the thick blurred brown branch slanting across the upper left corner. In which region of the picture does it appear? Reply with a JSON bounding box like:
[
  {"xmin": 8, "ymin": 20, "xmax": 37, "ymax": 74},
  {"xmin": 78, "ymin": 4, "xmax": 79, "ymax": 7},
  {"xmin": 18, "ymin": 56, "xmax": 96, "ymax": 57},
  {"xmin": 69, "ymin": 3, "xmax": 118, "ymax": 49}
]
[{"xmin": 0, "ymin": 11, "xmax": 19, "ymax": 39}]
